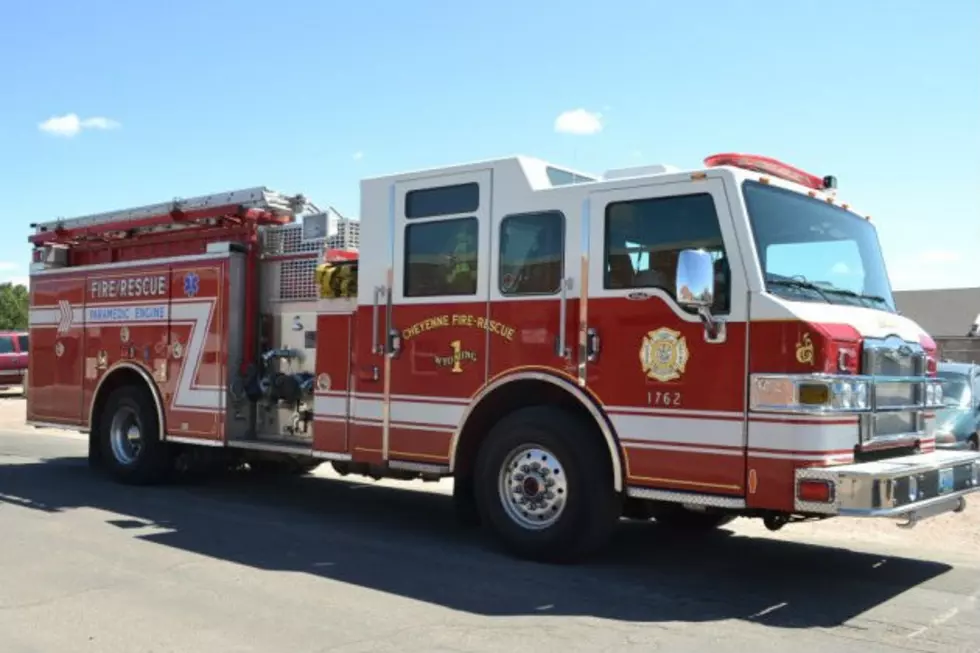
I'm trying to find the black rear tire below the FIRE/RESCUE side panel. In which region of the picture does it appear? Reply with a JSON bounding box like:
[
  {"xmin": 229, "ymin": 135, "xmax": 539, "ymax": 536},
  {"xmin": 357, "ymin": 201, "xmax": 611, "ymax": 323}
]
[{"xmin": 97, "ymin": 386, "xmax": 172, "ymax": 485}]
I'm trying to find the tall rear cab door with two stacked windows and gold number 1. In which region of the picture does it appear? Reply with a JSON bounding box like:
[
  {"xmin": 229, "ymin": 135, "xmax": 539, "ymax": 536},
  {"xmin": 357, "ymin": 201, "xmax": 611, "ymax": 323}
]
[{"xmin": 382, "ymin": 168, "xmax": 495, "ymax": 467}]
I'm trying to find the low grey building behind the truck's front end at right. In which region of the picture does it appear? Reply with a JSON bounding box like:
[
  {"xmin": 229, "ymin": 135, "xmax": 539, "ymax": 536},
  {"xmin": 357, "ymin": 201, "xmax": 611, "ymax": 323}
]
[{"xmin": 894, "ymin": 288, "xmax": 980, "ymax": 363}]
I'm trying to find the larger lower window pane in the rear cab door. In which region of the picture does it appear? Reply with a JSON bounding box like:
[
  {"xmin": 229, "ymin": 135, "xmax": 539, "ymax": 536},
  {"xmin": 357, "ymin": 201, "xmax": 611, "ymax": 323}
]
[{"xmin": 404, "ymin": 218, "xmax": 480, "ymax": 297}]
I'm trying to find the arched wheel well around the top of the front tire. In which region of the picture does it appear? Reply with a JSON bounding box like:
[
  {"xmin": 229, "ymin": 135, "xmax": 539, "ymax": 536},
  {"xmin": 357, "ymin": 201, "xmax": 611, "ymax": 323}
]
[{"xmin": 452, "ymin": 379, "xmax": 622, "ymax": 489}]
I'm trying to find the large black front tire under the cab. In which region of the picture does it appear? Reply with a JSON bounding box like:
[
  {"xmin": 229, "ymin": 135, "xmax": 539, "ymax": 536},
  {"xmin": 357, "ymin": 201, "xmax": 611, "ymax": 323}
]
[{"xmin": 474, "ymin": 406, "xmax": 622, "ymax": 563}]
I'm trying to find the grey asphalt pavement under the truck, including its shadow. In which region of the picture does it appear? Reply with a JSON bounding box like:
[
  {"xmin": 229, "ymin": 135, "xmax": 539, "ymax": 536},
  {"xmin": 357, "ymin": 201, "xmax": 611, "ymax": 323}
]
[{"xmin": 0, "ymin": 416, "xmax": 980, "ymax": 653}]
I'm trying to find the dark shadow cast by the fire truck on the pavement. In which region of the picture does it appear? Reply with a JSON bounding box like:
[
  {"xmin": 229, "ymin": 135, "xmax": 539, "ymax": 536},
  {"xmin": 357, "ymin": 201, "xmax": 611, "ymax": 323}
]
[{"xmin": 0, "ymin": 458, "xmax": 950, "ymax": 628}]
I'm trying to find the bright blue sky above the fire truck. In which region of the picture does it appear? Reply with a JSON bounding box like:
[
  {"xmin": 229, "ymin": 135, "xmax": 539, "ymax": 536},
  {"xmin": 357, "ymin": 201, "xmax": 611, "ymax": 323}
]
[{"xmin": 0, "ymin": 0, "xmax": 980, "ymax": 289}]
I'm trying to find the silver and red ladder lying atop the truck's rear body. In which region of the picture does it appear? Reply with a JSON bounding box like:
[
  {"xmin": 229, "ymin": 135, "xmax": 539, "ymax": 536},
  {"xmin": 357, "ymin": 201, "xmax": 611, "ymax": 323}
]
[{"xmin": 28, "ymin": 186, "xmax": 317, "ymax": 246}]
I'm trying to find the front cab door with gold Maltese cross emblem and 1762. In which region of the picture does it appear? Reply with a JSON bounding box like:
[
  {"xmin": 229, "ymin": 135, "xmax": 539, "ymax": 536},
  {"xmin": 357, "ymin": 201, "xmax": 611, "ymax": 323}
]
[{"xmin": 583, "ymin": 179, "xmax": 746, "ymax": 496}]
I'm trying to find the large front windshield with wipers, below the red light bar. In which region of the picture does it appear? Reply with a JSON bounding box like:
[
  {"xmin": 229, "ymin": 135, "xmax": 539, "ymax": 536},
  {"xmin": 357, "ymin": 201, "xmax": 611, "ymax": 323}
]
[{"xmin": 743, "ymin": 181, "xmax": 895, "ymax": 312}]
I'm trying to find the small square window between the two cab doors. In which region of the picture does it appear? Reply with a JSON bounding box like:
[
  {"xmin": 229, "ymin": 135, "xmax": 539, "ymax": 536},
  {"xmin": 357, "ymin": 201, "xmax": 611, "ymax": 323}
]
[{"xmin": 498, "ymin": 211, "xmax": 565, "ymax": 296}]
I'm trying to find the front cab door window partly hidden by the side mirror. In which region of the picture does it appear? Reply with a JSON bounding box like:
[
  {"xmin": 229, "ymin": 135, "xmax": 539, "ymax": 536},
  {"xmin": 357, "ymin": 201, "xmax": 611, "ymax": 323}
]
[{"xmin": 603, "ymin": 193, "xmax": 731, "ymax": 313}]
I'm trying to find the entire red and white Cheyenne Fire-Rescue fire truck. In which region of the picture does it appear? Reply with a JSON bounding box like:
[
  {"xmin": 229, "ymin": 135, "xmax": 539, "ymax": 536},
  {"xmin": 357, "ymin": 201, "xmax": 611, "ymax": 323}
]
[{"xmin": 27, "ymin": 154, "xmax": 980, "ymax": 561}]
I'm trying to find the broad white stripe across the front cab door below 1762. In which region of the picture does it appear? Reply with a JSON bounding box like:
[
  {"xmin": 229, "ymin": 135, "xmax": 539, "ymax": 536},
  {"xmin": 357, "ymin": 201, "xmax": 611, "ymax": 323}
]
[{"xmin": 610, "ymin": 415, "xmax": 744, "ymax": 447}]
